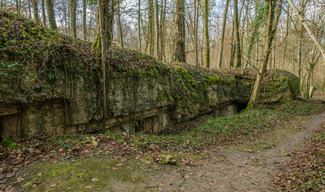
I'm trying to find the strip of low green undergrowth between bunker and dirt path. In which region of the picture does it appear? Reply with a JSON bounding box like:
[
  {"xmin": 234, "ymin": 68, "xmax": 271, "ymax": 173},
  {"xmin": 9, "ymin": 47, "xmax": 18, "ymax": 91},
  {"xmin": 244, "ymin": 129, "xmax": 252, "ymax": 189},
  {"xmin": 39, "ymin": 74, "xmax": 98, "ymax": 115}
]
[{"xmin": 105, "ymin": 100, "xmax": 325, "ymax": 151}]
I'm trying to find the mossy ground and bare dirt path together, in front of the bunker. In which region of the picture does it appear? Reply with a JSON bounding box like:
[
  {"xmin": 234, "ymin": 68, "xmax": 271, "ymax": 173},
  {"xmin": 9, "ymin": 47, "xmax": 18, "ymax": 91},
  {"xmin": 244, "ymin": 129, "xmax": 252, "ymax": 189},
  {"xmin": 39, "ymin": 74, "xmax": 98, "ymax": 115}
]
[{"xmin": 0, "ymin": 94, "xmax": 325, "ymax": 192}]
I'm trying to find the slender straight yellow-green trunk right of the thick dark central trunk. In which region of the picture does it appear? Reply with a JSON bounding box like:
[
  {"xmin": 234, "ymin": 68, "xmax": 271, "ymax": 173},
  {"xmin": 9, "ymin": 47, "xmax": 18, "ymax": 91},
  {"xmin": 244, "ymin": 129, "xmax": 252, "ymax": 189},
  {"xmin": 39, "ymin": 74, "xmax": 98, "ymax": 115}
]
[{"xmin": 204, "ymin": 0, "xmax": 210, "ymax": 68}]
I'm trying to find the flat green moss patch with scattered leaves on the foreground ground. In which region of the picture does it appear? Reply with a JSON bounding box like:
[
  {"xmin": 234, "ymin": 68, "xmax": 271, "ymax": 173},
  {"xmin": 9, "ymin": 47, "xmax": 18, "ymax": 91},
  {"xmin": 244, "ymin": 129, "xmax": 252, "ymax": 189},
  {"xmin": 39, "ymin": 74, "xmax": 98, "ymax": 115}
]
[{"xmin": 24, "ymin": 158, "xmax": 146, "ymax": 191}]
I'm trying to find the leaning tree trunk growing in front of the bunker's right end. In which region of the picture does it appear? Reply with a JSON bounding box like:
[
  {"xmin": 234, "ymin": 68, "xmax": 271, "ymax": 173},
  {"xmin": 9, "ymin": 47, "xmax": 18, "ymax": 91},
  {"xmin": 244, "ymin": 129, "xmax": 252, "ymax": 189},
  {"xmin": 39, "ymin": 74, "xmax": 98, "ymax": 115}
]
[{"xmin": 248, "ymin": 0, "xmax": 282, "ymax": 107}]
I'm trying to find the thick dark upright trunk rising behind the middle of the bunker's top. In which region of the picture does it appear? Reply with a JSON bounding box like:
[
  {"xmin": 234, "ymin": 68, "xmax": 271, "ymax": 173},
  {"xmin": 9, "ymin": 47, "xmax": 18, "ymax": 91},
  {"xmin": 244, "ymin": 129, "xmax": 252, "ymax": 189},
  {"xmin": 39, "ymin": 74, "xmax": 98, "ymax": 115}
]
[{"xmin": 175, "ymin": 0, "xmax": 186, "ymax": 62}]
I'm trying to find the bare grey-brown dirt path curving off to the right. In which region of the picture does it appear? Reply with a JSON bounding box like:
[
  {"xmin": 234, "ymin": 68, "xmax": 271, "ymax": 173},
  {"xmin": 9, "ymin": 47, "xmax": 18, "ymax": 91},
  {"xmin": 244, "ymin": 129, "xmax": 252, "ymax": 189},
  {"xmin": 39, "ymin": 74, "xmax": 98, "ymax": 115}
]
[{"xmin": 144, "ymin": 112, "xmax": 325, "ymax": 192}]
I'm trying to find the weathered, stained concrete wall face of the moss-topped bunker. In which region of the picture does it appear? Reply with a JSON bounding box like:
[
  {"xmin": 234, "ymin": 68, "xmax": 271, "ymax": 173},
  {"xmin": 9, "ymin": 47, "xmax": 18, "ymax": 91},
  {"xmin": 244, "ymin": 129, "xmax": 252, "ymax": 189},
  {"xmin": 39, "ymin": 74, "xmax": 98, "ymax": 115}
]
[{"xmin": 0, "ymin": 67, "xmax": 299, "ymax": 139}]
